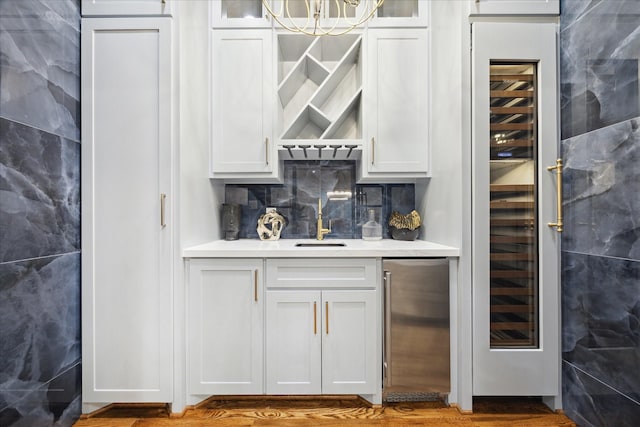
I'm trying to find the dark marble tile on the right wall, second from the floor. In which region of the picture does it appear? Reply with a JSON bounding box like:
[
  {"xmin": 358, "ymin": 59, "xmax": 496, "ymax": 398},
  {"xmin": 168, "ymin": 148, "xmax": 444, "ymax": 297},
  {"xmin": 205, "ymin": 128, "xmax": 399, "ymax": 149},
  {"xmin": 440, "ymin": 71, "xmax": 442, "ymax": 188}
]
[{"xmin": 562, "ymin": 252, "xmax": 640, "ymax": 402}]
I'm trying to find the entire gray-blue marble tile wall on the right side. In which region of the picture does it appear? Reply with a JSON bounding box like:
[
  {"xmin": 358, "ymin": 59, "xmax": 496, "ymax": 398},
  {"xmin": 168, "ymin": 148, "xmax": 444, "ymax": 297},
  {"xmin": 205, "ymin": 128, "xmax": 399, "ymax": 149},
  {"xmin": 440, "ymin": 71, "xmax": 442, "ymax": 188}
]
[{"xmin": 560, "ymin": 0, "xmax": 640, "ymax": 426}]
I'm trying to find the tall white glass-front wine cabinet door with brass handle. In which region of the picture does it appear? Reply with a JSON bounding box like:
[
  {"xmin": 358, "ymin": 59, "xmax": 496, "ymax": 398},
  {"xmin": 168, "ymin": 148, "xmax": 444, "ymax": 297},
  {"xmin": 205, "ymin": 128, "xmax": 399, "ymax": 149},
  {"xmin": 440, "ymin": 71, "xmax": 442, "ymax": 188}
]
[{"xmin": 472, "ymin": 22, "xmax": 561, "ymax": 408}]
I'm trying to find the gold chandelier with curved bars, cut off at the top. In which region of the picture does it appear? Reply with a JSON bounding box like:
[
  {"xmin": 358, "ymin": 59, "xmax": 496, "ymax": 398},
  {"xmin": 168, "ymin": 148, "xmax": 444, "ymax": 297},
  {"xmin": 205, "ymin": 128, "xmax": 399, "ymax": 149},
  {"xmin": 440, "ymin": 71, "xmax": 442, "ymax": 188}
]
[{"xmin": 262, "ymin": 0, "xmax": 384, "ymax": 36}]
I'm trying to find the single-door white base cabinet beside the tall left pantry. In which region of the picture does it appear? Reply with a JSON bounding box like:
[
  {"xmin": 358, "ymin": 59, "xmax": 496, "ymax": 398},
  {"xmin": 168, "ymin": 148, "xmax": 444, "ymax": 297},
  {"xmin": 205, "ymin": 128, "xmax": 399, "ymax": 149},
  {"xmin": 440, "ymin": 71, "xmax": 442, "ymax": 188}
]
[{"xmin": 187, "ymin": 259, "xmax": 264, "ymax": 395}]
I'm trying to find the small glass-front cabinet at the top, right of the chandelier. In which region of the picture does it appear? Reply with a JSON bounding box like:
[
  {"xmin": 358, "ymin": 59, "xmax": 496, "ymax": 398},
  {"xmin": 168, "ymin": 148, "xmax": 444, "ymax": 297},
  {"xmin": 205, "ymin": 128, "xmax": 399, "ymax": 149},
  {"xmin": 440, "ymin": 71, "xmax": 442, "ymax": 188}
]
[{"xmin": 368, "ymin": 0, "xmax": 429, "ymax": 28}]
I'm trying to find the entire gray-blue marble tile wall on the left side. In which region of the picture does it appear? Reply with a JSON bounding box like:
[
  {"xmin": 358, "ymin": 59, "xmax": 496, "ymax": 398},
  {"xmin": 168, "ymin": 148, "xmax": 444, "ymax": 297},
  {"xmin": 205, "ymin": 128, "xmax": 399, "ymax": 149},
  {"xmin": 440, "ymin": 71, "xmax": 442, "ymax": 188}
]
[{"xmin": 0, "ymin": 0, "xmax": 81, "ymax": 427}]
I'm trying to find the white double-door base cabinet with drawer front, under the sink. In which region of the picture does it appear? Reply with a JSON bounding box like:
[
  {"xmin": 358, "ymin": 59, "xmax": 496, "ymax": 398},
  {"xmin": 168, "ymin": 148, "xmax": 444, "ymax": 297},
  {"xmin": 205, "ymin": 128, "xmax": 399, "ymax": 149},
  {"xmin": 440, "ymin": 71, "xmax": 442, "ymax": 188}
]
[{"xmin": 265, "ymin": 259, "xmax": 381, "ymax": 395}]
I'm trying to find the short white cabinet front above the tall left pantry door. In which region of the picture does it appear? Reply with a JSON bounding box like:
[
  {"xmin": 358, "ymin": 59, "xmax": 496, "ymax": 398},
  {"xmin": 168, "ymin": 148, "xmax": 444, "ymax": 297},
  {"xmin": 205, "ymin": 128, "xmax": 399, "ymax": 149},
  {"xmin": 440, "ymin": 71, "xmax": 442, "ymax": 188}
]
[{"xmin": 82, "ymin": 0, "xmax": 175, "ymax": 16}]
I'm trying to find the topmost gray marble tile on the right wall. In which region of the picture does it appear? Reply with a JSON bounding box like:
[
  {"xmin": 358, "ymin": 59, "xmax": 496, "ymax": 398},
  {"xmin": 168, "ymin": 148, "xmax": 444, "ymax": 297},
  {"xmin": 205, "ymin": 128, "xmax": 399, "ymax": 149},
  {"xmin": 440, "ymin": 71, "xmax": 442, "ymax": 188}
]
[{"xmin": 560, "ymin": 0, "xmax": 640, "ymax": 138}]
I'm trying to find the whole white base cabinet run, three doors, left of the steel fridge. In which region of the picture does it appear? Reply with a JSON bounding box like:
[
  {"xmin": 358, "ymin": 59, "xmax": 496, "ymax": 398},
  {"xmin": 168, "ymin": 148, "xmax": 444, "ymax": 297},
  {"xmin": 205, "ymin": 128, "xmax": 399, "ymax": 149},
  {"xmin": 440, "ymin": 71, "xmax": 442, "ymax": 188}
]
[{"xmin": 187, "ymin": 258, "xmax": 382, "ymax": 403}]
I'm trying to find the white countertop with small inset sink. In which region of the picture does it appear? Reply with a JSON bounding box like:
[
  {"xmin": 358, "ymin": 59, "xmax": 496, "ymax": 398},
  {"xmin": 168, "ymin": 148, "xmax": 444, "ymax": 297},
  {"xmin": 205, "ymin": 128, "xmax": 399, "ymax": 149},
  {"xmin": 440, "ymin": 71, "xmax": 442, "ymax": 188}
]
[{"xmin": 182, "ymin": 239, "xmax": 460, "ymax": 258}]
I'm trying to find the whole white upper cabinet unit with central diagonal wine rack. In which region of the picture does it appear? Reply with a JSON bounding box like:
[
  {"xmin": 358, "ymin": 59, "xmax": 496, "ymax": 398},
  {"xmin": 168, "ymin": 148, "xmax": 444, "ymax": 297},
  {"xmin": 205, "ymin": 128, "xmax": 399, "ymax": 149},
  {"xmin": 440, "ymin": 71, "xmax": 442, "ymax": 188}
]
[{"xmin": 209, "ymin": 0, "xmax": 430, "ymax": 176}]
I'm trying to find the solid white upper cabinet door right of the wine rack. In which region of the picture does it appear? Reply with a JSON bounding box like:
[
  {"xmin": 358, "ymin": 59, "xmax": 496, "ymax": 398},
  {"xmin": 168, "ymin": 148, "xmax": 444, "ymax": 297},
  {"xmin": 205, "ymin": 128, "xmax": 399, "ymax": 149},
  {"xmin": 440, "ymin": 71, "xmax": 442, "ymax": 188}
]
[{"xmin": 362, "ymin": 28, "xmax": 429, "ymax": 179}]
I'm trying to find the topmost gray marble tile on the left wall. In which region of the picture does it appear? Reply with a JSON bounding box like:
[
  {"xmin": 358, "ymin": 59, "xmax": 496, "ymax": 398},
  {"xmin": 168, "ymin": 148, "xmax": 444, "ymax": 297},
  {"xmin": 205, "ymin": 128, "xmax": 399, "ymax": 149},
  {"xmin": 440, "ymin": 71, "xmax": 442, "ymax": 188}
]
[{"xmin": 0, "ymin": 0, "xmax": 80, "ymax": 141}]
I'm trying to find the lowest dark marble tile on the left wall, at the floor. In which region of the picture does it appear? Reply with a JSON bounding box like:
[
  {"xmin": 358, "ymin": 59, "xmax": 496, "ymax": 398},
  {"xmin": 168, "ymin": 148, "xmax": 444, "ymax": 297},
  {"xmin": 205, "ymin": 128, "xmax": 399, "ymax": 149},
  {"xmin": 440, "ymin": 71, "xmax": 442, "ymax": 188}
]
[{"xmin": 0, "ymin": 363, "xmax": 82, "ymax": 427}]
